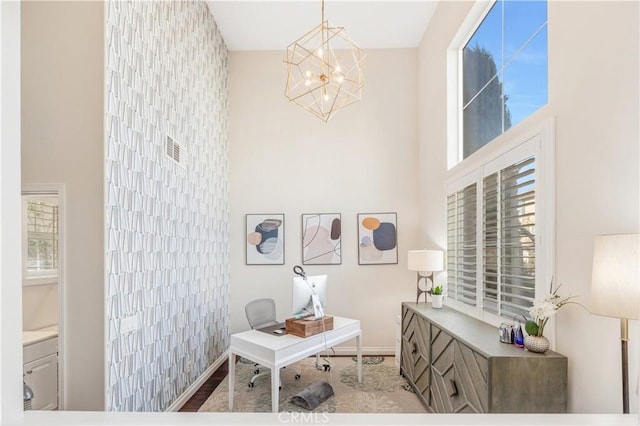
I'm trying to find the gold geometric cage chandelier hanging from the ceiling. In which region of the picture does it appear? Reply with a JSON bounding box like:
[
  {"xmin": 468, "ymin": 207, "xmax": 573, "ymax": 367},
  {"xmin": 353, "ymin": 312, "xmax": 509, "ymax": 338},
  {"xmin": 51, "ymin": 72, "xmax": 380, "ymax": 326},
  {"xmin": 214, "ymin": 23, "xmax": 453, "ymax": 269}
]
[{"xmin": 284, "ymin": 0, "xmax": 366, "ymax": 122}]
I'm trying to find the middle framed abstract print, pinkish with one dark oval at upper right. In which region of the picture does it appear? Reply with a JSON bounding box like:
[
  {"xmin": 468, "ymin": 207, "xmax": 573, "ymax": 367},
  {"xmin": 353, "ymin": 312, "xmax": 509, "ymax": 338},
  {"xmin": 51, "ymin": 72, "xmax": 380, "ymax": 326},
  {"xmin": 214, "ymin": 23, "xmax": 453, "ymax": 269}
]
[{"xmin": 302, "ymin": 213, "xmax": 342, "ymax": 265}]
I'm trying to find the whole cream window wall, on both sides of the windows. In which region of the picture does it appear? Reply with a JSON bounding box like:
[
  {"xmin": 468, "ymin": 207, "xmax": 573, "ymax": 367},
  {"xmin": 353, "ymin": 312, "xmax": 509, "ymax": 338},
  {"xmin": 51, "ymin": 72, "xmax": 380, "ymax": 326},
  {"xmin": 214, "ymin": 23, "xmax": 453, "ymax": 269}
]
[{"xmin": 418, "ymin": 1, "xmax": 640, "ymax": 413}]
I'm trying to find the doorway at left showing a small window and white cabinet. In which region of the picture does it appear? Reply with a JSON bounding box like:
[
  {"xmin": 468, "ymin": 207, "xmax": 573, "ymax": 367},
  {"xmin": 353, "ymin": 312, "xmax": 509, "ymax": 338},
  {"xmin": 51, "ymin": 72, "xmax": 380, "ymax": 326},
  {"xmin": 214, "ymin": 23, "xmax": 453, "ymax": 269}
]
[{"xmin": 22, "ymin": 184, "xmax": 65, "ymax": 410}]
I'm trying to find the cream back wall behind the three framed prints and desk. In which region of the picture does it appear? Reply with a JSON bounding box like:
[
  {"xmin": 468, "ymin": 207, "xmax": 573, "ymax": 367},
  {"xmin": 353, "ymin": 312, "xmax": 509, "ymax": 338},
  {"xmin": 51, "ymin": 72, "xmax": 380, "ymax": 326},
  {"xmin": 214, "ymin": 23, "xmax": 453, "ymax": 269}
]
[{"xmin": 229, "ymin": 50, "xmax": 418, "ymax": 353}]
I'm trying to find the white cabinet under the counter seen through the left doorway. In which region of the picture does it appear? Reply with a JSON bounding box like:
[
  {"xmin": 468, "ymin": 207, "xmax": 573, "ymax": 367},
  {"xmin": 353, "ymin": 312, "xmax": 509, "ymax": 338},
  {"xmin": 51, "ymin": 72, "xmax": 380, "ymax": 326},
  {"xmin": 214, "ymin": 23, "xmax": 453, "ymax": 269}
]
[{"xmin": 23, "ymin": 337, "xmax": 58, "ymax": 410}]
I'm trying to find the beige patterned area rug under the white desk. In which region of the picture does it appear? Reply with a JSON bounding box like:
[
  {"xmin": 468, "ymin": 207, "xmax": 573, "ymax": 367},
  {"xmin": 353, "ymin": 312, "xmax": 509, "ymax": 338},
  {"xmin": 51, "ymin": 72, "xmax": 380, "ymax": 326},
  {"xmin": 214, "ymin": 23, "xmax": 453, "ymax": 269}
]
[{"xmin": 198, "ymin": 356, "xmax": 426, "ymax": 413}]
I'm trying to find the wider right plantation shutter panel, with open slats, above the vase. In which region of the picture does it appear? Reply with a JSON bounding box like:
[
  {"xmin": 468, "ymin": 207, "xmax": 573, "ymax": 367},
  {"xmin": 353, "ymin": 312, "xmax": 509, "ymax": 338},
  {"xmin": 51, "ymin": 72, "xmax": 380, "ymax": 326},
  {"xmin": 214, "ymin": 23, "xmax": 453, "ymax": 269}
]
[{"xmin": 482, "ymin": 156, "xmax": 536, "ymax": 318}]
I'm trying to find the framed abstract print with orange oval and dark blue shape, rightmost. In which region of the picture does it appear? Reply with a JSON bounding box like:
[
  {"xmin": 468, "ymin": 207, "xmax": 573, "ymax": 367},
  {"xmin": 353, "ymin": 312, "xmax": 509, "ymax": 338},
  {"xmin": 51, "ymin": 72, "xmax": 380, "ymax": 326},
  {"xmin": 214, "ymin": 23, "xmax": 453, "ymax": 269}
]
[{"xmin": 358, "ymin": 213, "xmax": 398, "ymax": 265}]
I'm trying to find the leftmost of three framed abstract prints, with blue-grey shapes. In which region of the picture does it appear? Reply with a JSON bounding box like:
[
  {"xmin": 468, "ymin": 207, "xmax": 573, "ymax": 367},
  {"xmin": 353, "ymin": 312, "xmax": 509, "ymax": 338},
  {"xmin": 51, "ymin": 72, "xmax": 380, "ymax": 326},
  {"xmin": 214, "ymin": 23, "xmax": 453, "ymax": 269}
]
[{"xmin": 244, "ymin": 213, "xmax": 285, "ymax": 265}]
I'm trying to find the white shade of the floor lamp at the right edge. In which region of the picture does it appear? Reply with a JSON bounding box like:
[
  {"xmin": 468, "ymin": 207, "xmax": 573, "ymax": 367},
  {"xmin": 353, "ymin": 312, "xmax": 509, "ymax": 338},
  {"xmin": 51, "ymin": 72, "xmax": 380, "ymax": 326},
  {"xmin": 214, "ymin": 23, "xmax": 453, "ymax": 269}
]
[{"xmin": 591, "ymin": 234, "xmax": 640, "ymax": 319}]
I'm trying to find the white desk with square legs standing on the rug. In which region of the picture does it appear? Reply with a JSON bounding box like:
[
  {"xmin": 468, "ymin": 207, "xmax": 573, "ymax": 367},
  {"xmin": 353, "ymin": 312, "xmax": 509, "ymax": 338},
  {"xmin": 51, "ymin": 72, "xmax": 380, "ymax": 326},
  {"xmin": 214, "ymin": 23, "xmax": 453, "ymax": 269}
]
[{"xmin": 229, "ymin": 316, "xmax": 362, "ymax": 413}]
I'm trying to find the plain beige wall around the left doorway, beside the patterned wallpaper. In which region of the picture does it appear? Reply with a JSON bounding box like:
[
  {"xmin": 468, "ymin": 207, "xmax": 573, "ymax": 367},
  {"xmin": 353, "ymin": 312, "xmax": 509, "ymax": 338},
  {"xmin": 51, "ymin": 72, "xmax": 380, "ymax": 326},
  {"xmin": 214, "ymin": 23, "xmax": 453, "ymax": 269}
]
[{"xmin": 22, "ymin": 2, "xmax": 104, "ymax": 410}]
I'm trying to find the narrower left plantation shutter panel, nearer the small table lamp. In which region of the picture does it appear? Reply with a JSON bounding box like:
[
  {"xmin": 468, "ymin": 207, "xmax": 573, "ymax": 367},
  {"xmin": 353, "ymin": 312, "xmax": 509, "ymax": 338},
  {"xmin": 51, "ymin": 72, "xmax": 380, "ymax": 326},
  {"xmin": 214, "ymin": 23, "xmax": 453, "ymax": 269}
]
[{"xmin": 447, "ymin": 183, "xmax": 477, "ymax": 306}]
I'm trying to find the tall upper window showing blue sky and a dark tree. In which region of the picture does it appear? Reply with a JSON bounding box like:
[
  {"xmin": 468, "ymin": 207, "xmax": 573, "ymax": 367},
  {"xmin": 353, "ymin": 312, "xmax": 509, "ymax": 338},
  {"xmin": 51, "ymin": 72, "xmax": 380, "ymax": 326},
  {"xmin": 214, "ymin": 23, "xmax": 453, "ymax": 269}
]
[{"xmin": 458, "ymin": 0, "xmax": 548, "ymax": 161}]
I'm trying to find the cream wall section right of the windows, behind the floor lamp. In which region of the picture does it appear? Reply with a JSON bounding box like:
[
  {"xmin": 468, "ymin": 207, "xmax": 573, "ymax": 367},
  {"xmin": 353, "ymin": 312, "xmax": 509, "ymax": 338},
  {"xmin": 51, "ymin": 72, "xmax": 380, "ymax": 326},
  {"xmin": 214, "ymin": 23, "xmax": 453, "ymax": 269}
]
[{"xmin": 549, "ymin": 2, "xmax": 640, "ymax": 413}]
